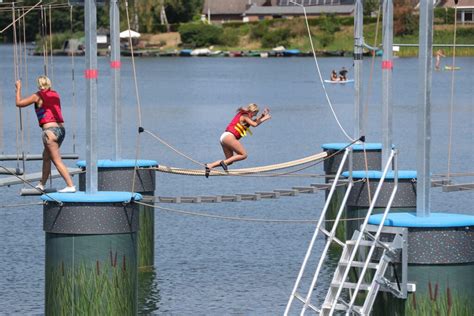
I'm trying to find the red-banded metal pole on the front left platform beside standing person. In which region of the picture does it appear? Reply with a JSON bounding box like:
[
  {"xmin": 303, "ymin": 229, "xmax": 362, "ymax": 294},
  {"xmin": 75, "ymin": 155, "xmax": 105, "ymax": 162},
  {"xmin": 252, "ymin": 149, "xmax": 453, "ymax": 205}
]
[{"xmin": 84, "ymin": 0, "xmax": 98, "ymax": 193}]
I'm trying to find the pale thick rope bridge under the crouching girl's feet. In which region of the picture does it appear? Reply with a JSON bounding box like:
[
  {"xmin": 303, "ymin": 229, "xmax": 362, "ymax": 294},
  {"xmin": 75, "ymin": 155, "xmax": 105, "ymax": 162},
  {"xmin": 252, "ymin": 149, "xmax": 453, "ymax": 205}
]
[{"xmin": 152, "ymin": 152, "xmax": 328, "ymax": 176}]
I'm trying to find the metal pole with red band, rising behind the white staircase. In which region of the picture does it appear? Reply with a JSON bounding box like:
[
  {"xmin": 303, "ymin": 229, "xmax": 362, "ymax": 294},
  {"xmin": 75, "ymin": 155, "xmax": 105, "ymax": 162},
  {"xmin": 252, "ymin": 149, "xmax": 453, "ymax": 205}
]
[{"xmin": 382, "ymin": 0, "xmax": 393, "ymax": 166}]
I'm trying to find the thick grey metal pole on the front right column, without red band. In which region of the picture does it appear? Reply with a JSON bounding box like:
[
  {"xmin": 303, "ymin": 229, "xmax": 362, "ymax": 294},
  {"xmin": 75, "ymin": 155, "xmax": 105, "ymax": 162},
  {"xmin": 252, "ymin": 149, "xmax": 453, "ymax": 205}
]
[{"xmin": 416, "ymin": 1, "xmax": 433, "ymax": 216}]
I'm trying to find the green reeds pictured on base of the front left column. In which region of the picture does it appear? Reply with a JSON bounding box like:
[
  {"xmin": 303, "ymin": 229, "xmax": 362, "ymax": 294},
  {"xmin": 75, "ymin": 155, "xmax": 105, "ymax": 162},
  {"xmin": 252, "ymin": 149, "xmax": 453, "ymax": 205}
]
[{"xmin": 45, "ymin": 252, "xmax": 137, "ymax": 315}]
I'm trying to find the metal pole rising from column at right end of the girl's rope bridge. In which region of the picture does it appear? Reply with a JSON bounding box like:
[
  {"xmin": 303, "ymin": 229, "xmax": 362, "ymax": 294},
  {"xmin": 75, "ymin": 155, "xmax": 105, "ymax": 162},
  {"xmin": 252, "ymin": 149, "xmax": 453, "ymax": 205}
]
[{"xmin": 354, "ymin": 0, "xmax": 365, "ymax": 139}]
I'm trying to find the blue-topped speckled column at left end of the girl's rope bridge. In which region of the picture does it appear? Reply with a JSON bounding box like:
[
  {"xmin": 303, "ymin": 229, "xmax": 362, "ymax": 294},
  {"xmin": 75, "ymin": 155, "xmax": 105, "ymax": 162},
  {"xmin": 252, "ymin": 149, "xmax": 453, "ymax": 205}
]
[{"xmin": 77, "ymin": 160, "xmax": 158, "ymax": 270}]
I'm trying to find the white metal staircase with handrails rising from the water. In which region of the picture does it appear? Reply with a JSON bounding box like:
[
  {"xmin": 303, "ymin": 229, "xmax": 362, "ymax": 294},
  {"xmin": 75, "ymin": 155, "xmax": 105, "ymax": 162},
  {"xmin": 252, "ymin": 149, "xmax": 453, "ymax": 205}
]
[{"xmin": 284, "ymin": 148, "xmax": 406, "ymax": 315}]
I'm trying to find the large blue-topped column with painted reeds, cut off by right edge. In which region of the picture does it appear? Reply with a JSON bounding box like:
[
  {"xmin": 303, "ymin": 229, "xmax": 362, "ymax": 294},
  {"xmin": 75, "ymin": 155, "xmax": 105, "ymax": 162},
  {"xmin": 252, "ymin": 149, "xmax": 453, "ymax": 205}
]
[{"xmin": 369, "ymin": 210, "xmax": 474, "ymax": 315}]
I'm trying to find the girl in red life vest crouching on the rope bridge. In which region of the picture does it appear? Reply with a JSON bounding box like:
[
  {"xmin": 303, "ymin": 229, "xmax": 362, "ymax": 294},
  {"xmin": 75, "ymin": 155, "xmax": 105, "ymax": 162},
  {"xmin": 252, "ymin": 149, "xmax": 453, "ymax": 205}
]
[{"xmin": 205, "ymin": 103, "xmax": 272, "ymax": 178}]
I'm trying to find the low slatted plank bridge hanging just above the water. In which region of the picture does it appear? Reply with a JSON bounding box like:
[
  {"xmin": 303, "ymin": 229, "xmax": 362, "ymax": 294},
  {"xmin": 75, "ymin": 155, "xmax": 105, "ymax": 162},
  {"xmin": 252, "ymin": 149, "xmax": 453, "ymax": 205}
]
[{"xmin": 134, "ymin": 201, "xmax": 365, "ymax": 224}]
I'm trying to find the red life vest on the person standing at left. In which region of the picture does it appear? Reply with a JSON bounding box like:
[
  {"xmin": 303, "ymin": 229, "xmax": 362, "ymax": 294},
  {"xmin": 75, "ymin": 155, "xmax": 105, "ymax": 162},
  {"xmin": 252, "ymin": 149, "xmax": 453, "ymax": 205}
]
[{"xmin": 35, "ymin": 89, "xmax": 64, "ymax": 126}]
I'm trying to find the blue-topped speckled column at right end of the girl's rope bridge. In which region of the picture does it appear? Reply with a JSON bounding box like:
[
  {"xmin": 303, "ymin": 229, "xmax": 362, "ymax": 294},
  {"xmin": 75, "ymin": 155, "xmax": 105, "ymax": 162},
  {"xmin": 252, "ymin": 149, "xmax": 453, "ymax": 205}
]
[{"xmin": 322, "ymin": 143, "xmax": 382, "ymax": 241}]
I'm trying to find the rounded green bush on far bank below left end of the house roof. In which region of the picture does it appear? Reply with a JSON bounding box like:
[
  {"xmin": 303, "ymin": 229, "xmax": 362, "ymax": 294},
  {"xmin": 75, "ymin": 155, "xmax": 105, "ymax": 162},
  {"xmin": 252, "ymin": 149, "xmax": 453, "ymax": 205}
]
[{"xmin": 179, "ymin": 23, "xmax": 223, "ymax": 47}]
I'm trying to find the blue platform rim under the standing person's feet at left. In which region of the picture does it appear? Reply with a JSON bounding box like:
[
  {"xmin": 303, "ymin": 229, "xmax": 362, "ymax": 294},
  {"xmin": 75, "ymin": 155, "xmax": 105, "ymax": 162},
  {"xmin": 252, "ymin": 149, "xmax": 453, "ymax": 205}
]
[{"xmin": 41, "ymin": 191, "xmax": 143, "ymax": 203}]
